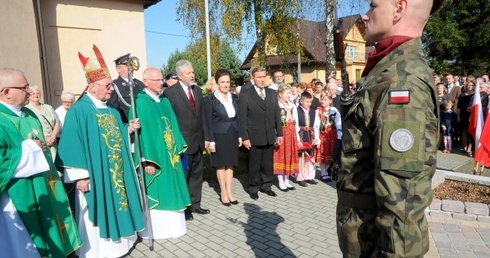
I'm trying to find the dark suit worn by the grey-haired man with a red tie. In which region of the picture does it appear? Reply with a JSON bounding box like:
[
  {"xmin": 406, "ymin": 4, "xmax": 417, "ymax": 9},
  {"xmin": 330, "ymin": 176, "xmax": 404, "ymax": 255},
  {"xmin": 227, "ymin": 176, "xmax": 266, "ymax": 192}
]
[{"xmin": 164, "ymin": 82, "xmax": 209, "ymax": 211}]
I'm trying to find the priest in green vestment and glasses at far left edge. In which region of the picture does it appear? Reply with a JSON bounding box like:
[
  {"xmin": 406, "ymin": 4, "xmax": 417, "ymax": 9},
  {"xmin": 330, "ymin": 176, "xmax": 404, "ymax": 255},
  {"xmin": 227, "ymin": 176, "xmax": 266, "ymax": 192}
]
[{"xmin": 0, "ymin": 68, "xmax": 82, "ymax": 257}]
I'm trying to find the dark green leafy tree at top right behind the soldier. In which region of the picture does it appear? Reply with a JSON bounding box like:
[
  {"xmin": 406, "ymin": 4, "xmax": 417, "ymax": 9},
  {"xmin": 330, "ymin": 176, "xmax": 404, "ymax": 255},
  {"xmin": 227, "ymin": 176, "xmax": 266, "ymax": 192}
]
[{"xmin": 423, "ymin": 0, "xmax": 490, "ymax": 75}]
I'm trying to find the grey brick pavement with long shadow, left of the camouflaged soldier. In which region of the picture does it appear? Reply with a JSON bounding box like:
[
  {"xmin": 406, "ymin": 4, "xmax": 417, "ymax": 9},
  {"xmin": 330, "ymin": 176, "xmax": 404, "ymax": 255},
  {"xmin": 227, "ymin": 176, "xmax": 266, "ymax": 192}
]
[{"xmin": 129, "ymin": 175, "xmax": 342, "ymax": 257}]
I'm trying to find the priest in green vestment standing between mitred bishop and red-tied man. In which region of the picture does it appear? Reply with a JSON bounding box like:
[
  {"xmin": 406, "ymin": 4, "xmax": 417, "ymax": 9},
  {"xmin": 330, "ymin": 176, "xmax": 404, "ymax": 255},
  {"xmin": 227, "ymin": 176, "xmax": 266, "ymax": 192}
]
[{"xmin": 130, "ymin": 68, "xmax": 191, "ymax": 239}]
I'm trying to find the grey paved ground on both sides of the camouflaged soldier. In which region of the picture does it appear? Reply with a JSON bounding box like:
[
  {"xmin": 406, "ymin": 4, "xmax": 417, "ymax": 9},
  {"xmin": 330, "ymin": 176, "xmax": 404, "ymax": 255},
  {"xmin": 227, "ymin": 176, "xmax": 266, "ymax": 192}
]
[{"xmin": 128, "ymin": 150, "xmax": 490, "ymax": 258}]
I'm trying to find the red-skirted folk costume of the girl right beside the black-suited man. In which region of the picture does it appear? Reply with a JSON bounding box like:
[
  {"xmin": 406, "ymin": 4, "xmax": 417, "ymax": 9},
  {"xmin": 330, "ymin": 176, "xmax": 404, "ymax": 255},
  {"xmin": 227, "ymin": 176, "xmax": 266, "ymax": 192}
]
[{"xmin": 274, "ymin": 102, "xmax": 300, "ymax": 191}]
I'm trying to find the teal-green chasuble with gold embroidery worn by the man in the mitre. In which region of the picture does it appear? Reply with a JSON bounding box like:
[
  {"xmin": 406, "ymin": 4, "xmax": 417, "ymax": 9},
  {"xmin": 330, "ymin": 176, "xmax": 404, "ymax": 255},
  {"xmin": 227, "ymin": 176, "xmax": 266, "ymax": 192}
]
[{"xmin": 56, "ymin": 95, "xmax": 145, "ymax": 241}]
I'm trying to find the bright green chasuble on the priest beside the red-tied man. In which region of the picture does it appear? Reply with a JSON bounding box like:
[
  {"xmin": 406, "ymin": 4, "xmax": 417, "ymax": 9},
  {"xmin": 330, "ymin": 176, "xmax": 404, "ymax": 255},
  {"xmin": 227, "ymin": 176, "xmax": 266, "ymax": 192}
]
[{"xmin": 129, "ymin": 92, "xmax": 191, "ymax": 211}]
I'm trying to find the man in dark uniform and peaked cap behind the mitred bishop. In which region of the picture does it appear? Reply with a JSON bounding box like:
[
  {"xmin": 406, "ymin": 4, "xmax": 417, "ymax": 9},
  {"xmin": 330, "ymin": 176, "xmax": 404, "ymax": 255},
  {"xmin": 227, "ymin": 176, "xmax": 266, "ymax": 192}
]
[{"xmin": 108, "ymin": 54, "xmax": 145, "ymax": 123}]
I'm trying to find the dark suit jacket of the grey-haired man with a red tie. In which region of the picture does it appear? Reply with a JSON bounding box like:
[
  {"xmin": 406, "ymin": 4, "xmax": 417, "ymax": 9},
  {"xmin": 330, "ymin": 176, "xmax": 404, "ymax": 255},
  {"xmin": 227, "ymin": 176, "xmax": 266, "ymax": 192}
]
[{"xmin": 163, "ymin": 81, "xmax": 209, "ymax": 154}]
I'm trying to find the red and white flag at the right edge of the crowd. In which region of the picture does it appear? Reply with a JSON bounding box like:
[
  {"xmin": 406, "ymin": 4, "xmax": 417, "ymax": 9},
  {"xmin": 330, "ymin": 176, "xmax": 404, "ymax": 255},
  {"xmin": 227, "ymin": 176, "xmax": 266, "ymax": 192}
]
[{"xmin": 468, "ymin": 83, "xmax": 490, "ymax": 167}]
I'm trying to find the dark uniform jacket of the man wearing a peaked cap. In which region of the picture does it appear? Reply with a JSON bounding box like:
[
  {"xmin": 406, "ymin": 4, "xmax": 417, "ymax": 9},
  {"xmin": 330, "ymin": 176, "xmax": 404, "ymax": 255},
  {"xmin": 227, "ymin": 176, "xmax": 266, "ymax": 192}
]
[{"xmin": 108, "ymin": 76, "xmax": 145, "ymax": 123}]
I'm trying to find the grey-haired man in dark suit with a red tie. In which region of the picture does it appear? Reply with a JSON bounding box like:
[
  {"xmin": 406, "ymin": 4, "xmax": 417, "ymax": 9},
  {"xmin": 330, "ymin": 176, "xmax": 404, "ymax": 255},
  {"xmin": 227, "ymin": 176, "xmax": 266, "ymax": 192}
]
[{"xmin": 164, "ymin": 60, "xmax": 210, "ymax": 220}]
